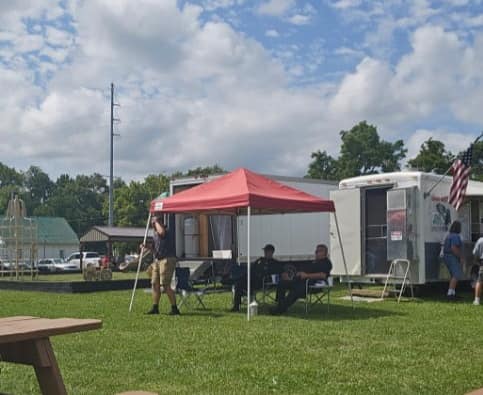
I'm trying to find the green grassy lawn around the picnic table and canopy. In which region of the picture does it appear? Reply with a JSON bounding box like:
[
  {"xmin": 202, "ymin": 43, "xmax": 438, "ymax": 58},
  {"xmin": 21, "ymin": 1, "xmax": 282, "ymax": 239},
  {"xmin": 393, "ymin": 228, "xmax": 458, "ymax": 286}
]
[{"xmin": 0, "ymin": 290, "xmax": 483, "ymax": 395}]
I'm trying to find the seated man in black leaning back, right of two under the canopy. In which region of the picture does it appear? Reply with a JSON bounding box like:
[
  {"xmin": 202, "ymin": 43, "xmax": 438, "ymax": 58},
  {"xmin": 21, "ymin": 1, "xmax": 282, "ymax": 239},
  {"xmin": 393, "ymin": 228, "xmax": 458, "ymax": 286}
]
[{"xmin": 270, "ymin": 244, "xmax": 332, "ymax": 315}]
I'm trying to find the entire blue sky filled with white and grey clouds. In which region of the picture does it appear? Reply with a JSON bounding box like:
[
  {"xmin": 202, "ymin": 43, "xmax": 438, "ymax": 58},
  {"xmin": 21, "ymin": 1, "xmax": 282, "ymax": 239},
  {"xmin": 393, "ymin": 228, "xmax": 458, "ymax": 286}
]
[{"xmin": 0, "ymin": 0, "xmax": 483, "ymax": 180}]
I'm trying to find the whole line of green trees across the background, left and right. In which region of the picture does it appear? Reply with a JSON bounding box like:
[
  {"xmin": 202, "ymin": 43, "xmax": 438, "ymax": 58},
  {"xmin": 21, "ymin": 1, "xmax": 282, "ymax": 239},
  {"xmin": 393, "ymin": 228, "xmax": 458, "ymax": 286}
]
[{"xmin": 0, "ymin": 121, "xmax": 483, "ymax": 236}]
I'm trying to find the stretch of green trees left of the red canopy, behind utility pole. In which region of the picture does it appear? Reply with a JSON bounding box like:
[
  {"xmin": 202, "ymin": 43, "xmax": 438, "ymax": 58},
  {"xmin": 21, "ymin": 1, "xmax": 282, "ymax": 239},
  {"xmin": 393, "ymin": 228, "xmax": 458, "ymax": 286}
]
[{"xmin": 0, "ymin": 163, "xmax": 224, "ymax": 237}]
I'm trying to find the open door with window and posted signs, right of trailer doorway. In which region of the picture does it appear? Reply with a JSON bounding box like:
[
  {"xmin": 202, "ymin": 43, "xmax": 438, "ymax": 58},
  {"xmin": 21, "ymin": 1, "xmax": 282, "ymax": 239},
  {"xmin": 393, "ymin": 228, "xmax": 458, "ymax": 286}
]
[{"xmin": 387, "ymin": 187, "xmax": 417, "ymax": 272}]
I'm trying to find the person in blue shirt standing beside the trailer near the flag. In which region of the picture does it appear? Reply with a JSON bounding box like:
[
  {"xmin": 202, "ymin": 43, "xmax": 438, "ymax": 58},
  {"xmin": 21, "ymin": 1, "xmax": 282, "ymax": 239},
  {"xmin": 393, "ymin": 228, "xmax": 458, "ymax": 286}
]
[{"xmin": 443, "ymin": 221, "xmax": 463, "ymax": 300}]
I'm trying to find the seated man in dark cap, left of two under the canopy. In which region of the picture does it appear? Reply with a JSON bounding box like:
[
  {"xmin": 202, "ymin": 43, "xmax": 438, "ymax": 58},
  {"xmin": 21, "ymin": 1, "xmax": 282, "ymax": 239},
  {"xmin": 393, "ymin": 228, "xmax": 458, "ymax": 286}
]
[{"xmin": 231, "ymin": 244, "xmax": 282, "ymax": 311}]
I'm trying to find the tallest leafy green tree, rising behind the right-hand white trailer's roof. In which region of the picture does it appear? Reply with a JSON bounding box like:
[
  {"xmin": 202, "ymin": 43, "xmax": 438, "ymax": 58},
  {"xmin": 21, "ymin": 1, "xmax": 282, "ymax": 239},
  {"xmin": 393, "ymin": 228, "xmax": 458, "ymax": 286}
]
[{"xmin": 337, "ymin": 121, "xmax": 407, "ymax": 178}]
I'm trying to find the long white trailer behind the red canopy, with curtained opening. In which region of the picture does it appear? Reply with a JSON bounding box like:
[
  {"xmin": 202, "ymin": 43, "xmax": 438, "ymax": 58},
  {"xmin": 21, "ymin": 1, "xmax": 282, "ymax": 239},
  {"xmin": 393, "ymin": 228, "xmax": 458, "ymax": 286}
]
[{"xmin": 170, "ymin": 175, "xmax": 337, "ymax": 262}]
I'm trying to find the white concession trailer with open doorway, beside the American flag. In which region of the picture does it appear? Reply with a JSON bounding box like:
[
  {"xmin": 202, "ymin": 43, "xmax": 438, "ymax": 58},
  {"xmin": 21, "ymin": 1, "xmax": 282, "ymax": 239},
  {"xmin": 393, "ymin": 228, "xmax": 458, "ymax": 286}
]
[{"xmin": 330, "ymin": 172, "xmax": 483, "ymax": 284}]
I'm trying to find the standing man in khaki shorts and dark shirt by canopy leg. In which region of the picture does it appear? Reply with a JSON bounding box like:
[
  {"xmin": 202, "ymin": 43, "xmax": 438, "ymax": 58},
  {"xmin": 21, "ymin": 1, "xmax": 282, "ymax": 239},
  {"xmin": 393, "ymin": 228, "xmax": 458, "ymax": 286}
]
[{"xmin": 146, "ymin": 216, "xmax": 179, "ymax": 315}]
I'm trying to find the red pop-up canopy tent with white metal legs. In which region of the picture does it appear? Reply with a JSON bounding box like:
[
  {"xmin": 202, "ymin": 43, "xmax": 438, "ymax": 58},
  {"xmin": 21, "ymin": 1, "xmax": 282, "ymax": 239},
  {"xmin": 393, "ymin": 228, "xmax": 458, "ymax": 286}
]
[{"xmin": 130, "ymin": 168, "xmax": 352, "ymax": 318}]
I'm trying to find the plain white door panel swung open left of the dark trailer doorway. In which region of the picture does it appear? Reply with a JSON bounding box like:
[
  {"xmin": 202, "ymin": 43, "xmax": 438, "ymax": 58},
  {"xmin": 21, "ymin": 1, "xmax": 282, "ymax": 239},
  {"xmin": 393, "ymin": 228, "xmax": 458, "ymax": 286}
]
[{"xmin": 330, "ymin": 189, "xmax": 362, "ymax": 276}]
